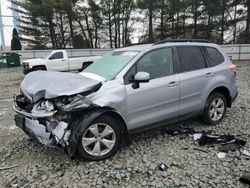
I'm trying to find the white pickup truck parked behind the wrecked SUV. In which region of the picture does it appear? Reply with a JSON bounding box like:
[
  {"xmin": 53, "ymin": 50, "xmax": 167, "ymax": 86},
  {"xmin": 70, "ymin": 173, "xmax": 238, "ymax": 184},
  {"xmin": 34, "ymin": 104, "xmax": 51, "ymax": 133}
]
[{"xmin": 22, "ymin": 50, "xmax": 101, "ymax": 74}]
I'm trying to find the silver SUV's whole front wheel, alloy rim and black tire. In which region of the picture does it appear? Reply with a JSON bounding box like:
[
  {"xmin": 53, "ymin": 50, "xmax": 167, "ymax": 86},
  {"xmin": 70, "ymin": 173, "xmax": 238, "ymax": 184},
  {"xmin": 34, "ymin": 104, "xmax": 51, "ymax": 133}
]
[{"xmin": 77, "ymin": 116, "xmax": 122, "ymax": 161}]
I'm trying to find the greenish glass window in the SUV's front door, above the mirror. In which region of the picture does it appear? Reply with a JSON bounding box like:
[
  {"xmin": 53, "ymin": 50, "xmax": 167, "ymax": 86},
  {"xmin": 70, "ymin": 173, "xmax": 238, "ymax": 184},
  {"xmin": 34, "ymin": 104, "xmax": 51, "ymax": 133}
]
[{"xmin": 137, "ymin": 48, "xmax": 174, "ymax": 79}]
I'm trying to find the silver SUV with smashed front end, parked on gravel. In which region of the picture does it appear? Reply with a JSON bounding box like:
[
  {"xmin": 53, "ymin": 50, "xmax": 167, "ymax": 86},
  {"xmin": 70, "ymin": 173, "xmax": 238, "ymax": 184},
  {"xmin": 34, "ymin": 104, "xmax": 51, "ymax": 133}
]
[{"xmin": 14, "ymin": 40, "xmax": 238, "ymax": 160}]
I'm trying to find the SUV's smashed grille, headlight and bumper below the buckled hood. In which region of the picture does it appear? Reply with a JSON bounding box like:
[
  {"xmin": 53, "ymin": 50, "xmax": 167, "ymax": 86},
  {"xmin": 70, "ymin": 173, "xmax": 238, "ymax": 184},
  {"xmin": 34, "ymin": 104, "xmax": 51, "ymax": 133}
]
[{"xmin": 13, "ymin": 94, "xmax": 91, "ymax": 147}]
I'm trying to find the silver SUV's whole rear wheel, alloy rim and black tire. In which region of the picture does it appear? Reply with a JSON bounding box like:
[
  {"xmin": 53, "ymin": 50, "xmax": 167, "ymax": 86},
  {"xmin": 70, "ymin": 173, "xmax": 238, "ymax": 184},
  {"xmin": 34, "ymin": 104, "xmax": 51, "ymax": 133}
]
[{"xmin": 203, "ymin": 92, "xmax": 227, "ymax": 125}]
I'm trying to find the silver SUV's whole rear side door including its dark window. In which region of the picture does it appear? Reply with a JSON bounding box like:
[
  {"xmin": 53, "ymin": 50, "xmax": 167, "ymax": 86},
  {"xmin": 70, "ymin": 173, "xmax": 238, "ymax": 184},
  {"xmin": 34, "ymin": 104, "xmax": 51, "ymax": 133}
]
[{"xmin": 177, "ymin": 46, "xmax": 213, "ymax": 116}]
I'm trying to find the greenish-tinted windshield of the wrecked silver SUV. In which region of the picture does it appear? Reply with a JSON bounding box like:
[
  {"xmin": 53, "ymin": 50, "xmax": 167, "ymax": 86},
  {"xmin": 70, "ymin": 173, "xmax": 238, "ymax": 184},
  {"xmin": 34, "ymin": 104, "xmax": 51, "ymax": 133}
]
[{"xmin": 83, "ymin": 51, "xmax": 138, "ymax": 80}]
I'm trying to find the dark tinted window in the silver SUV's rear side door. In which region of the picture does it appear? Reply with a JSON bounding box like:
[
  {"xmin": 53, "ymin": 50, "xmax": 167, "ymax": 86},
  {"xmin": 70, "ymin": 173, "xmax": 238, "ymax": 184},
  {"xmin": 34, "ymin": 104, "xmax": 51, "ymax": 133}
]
[{"xmin": 177, "ymin": 46, "xmax": 207, "ymax": 73}]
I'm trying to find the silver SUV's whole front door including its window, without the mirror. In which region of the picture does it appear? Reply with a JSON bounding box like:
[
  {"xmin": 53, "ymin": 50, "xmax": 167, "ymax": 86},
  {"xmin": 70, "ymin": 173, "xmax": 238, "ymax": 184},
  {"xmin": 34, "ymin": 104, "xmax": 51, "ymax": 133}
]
[{"xmin": 124, "ymin": 47, "xmax": 180, "ymax": 129}]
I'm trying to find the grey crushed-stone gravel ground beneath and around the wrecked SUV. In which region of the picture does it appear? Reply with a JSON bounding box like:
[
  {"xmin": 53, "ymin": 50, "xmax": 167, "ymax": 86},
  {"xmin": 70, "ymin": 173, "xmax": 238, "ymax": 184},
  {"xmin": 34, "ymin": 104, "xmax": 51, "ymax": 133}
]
[{"xmin": 0, "ymin": 63, "xmax": 250, "ymax": 188}]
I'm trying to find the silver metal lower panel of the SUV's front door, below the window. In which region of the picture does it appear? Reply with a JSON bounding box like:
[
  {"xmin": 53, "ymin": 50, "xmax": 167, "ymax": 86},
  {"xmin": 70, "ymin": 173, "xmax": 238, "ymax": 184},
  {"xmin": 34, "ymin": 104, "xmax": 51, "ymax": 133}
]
[{"xmin": 126, "ymin": 75, "xmax": 179, "ymax": 129}]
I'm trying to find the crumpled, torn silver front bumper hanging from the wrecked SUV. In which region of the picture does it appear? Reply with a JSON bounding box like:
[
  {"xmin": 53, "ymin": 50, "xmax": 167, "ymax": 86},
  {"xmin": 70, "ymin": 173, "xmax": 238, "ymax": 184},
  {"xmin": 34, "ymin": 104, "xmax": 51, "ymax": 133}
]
[{"xmin": 13, "ymin": 98, "xmax": 70, "ymax": 147}]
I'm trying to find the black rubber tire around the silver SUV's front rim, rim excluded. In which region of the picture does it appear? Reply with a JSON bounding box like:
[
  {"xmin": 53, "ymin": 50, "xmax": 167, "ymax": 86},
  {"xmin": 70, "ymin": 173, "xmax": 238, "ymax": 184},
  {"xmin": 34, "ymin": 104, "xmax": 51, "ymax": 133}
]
[{"xmin": 77, "ymin": 115, "xmax": 122, "ymax": 161}]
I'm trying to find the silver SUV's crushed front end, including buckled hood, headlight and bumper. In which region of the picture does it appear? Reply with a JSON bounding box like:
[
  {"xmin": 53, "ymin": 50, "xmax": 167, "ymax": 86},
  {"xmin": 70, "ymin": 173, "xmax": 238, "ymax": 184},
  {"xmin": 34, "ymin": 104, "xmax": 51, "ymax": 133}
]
[{"xmin": 13, "ymin": 72, "xmax": 102, "ymax": 151}]
